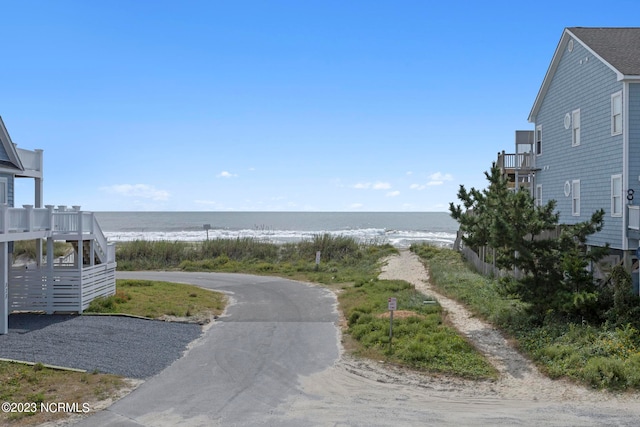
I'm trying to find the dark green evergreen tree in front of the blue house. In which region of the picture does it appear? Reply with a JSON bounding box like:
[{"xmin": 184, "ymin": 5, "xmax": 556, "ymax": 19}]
[{"xmin": 449, "ymin": 163, "xmax": 608, "ymax": 320}]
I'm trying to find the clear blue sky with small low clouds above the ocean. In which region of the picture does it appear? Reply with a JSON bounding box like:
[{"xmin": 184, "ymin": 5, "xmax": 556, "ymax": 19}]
[{"xmin": 0, "ymin": 0, "xmax": 640, "ymax": 212}]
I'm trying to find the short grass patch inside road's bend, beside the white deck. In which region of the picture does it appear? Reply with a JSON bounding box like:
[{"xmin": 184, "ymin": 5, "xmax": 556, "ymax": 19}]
[{"xmin": 85, "ymin": 280, "xmax": 226, "ymax": 319}]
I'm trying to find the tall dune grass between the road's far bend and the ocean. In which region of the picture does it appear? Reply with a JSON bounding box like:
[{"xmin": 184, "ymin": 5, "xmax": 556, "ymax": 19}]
[{"xmin": 116, "ymin": 234, "xmax": 395, "ymax": 283}]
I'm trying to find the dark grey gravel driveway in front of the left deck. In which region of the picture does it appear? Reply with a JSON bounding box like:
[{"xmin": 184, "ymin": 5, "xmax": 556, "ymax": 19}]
[{"xmin": 0, "ymin": 314, "xmax": 202, "ymax": 379}]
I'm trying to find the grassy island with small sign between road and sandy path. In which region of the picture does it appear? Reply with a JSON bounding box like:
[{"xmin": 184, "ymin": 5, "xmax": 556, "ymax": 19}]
[{"xmin": 339, "ymin": 280, "xmax": 498, "ymax": 379}]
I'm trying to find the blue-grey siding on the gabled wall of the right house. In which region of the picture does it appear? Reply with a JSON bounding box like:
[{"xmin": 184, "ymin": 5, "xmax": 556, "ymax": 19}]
[{"xmin": 535, "ymin": 38, "xmax": 623, "ymax": 248}]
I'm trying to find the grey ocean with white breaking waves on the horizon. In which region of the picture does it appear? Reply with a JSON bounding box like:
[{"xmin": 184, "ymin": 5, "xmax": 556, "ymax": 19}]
[{"xmin": 95, "ymin": 211, "xmax": 458, "ymax": 248}]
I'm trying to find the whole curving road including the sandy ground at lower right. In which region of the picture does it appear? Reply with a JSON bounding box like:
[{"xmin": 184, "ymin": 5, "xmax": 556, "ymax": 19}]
[{"xmin": 72, "ymin": 272, "xmax": 640, "ymax": 427}]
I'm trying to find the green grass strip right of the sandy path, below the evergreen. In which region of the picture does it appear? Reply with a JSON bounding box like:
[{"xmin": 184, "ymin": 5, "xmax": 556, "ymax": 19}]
[{"xmin": 411, "ymin": 245, "xmax": 640, "ymax": 390}]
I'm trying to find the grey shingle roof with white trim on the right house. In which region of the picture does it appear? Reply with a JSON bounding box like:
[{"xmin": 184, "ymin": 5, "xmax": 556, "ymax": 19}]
[{"xmin": 529, "ymin": 27, "xmax": 640, "ymax": 122}]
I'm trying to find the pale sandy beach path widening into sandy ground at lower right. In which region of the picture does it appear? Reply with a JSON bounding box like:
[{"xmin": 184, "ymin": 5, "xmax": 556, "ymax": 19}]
[{"xmin": 278, "ymin": 251, "xmax": 640, "ymax": 427}]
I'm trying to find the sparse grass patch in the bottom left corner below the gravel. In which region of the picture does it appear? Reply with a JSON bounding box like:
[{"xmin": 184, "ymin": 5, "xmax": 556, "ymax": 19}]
[{"xmin": 0, "ymin": 362, "xmax": 127, "ymax": 426}]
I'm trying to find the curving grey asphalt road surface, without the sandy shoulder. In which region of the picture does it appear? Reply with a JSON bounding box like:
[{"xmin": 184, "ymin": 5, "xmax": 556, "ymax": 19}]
[{"xmin": 76, "ymin": 272, "xmax": 339, "ymax": 427}]
